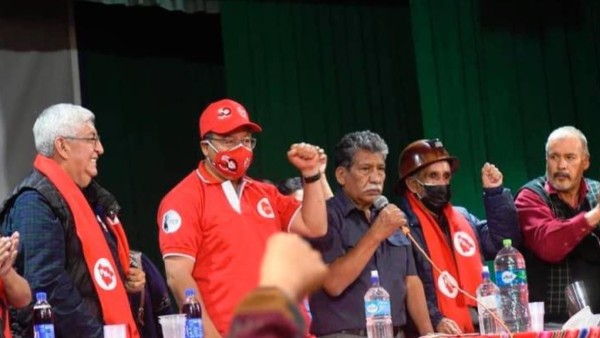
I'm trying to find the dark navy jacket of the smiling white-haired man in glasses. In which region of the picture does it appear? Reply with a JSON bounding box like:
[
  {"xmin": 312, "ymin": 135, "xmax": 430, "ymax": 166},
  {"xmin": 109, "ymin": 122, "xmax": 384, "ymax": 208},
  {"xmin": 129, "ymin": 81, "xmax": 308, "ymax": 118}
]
[{"xmin": 0, "ymin": 170, "xmax": 124, "ymax": 338}]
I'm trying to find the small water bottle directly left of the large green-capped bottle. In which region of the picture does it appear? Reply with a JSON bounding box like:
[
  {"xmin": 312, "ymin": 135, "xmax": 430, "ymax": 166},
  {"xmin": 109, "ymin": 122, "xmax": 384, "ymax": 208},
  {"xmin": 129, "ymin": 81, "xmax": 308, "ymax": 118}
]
[{"xmin": 477, "ymin": 266, "xmax": 504, "ymax": 335}]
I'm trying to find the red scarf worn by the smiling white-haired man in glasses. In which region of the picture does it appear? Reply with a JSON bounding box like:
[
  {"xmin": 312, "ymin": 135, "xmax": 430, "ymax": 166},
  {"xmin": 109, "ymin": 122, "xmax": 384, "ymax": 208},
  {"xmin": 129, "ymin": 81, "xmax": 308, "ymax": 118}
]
[{"xmin": 33, "ymin": 155, "xmax": 140, "ymax": 338}]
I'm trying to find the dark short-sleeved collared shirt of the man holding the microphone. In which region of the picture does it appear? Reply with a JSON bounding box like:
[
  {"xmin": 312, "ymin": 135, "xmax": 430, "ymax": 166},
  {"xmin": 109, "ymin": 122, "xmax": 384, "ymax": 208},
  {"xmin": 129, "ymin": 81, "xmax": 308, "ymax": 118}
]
[{"xmin": 310, "ymin": 190, "xmax": 416, "ymax": 335}]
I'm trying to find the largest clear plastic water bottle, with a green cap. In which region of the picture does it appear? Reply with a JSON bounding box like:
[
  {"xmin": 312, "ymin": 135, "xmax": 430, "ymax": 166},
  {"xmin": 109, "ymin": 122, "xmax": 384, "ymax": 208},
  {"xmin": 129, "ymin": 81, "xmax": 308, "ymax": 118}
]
[{"xmin": 494, "ymin": 239, "xmax": 531, "ymax": 333}]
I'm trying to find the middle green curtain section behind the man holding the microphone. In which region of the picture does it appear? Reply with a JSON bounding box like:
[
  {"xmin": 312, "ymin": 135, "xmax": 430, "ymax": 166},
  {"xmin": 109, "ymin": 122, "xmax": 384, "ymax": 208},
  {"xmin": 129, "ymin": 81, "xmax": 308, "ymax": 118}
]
[{"xmin": 221, "ymin": 0, "xmax": 422, "ymax": 193}]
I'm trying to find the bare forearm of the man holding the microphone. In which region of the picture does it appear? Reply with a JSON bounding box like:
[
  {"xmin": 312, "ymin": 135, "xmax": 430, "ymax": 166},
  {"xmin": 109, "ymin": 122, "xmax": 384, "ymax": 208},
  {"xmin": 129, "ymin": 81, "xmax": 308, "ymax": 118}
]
[{"xmin": 323, "ymin": 233, "xmax": 379, "ymax": 296}]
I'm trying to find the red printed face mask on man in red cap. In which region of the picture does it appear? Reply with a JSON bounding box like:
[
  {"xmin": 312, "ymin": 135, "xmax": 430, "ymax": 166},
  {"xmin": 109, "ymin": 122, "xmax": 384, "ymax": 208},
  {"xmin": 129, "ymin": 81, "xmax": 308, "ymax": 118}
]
[{"xmin": 207, "ymin": 142, "xmax": 253, "ymax": 180}]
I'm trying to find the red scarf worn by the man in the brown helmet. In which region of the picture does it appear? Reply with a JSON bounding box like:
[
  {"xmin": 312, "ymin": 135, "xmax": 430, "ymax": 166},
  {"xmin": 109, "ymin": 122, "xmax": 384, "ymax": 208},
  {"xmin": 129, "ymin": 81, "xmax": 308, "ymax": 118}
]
[{"xmin": 406, "ymin": 192, "xmax": 482, "ymax": 332}]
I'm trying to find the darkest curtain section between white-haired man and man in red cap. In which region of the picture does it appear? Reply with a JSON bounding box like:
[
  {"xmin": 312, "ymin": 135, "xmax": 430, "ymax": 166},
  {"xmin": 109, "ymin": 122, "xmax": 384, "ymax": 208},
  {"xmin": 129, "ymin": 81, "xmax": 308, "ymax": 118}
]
[{"xmin": 75, "ymin": 2, "xmax": 225, "ymax": 262}]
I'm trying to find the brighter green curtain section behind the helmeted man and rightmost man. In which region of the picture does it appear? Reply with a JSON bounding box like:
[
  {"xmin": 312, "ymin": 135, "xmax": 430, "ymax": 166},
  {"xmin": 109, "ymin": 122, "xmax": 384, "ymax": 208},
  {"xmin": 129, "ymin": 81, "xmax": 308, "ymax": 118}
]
[{"xmin": 410, "ymin": 0, "xmax": 600, "ymax": 215}]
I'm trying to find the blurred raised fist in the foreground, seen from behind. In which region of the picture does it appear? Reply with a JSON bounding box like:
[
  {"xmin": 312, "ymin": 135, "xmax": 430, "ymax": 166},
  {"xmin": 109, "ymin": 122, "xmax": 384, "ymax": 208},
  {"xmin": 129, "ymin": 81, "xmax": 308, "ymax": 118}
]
[{"xmin": 259, "ymin": 233, "xmax": 327, "ymax": 301}]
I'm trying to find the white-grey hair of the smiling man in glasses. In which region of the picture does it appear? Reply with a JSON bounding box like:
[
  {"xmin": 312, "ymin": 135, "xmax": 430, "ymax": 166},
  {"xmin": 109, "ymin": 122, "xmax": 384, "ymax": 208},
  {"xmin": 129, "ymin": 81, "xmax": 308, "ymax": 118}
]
[{"xmin": 33, "ymin": 103, "xmax": 94, "ymax": 157}]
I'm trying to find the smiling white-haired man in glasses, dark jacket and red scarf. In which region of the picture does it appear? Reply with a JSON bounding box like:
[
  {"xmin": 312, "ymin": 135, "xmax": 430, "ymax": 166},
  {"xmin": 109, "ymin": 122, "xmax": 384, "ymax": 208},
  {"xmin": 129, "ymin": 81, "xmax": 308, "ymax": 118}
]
[{"xmin": 0, "ymin": 104, "xmax": 145, "ymax": 338}]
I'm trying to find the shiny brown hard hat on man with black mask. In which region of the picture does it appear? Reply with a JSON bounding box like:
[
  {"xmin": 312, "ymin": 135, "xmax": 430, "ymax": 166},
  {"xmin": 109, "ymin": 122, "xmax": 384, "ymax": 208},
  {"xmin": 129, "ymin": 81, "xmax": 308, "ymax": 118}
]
[{"xmin": 394, "ymin": 138, "xmax": 458, "ymax": 192}]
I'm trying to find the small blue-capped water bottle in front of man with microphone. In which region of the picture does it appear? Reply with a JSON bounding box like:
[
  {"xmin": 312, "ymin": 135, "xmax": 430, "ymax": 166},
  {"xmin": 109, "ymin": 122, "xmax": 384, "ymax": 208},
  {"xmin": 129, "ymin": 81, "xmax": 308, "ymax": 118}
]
[{"xmin": 365, "ymin": 270, "xmax": 394, "ymax": 338}]
